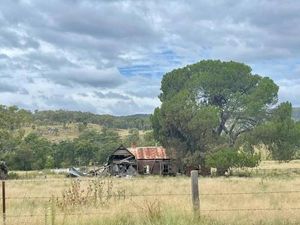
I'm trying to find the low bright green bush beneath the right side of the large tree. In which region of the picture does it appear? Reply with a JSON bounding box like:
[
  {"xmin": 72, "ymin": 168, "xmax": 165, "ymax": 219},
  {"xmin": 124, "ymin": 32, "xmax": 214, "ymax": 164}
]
[{"xmin": 206, "ymin": 148, "xmax": 260, "ymax": 175}]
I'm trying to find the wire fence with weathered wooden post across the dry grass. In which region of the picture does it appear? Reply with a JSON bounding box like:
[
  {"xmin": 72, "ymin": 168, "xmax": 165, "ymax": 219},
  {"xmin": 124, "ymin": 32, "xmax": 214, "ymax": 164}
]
[{"xmin": 1, "ymin": 171, "xmax": 300, "ymax": 225}]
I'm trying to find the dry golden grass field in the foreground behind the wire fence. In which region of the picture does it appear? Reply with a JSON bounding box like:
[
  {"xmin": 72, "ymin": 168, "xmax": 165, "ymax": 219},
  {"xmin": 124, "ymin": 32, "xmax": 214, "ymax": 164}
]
[{"xmin": 1, "ymin": 161, "xmax": 300, "ymax": 225}]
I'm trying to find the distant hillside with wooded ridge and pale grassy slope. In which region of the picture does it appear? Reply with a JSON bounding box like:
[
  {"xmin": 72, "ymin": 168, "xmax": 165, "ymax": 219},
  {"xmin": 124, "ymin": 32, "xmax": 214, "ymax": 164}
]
[{"xmin": 12, "ymin": 108, "xmax": 300, "ymax": 142}]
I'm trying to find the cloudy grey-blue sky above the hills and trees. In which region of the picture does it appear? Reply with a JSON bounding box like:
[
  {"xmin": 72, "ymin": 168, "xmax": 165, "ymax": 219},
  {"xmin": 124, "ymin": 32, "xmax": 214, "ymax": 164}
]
[{"xmin": 0, "ymin": 0, "xmax": 300, "ymax": 115}]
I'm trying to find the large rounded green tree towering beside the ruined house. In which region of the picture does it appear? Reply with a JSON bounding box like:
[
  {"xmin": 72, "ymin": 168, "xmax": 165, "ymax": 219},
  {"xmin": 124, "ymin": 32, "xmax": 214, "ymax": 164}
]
[{"xmin": 151, "ymin": 60, "xmax": 278, "ymax": 168}]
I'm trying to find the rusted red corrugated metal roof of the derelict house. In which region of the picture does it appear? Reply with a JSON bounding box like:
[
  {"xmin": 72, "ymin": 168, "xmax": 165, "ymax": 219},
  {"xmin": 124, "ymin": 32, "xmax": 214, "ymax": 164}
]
[{"xmin": 128, "ymin": 147, "xmax": 169, "ymax": 159}]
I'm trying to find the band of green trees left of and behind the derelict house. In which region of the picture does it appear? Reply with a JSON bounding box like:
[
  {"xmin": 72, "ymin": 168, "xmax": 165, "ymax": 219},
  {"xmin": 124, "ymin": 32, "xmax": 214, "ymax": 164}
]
[{"xmin": 0, "ymin": 106, "xmax": 155, "ymax": 170}]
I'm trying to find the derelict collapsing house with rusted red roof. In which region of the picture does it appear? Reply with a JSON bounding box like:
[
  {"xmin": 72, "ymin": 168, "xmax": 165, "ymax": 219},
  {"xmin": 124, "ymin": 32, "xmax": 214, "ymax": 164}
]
[{"xmin": 108, "ymin": 145, "xmax": 175, "ymax": 176}]
